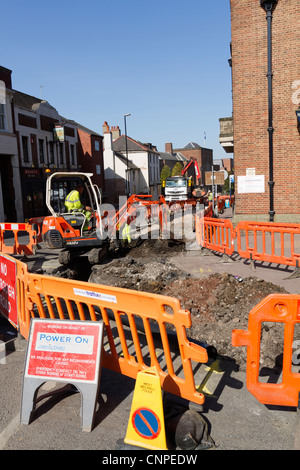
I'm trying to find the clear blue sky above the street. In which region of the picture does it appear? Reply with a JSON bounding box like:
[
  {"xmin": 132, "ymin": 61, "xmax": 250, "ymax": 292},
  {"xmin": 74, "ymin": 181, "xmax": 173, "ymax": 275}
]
[{"xmin": 0, "ymin": 0, "xmax": 232, "ymax": 159}]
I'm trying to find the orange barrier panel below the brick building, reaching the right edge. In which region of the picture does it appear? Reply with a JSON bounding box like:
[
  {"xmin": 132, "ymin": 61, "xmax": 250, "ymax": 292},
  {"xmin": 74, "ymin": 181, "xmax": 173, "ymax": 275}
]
[{"xmin": 235, "ymin": 222, "xmax": 300, "ymax": 266}]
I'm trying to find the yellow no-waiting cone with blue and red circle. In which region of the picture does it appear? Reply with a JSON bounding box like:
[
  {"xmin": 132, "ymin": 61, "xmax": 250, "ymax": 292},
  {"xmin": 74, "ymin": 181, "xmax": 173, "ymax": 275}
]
[{"xmin": 124, "ymin": 367, "xmax": 168, "ymax": 450}]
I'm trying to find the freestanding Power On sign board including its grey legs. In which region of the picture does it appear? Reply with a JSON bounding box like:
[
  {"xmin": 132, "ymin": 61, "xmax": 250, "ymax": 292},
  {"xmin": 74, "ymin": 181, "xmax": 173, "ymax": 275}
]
[{"xmin": 20, "ymin": 318, "xmax": 104, "ymax": 431}]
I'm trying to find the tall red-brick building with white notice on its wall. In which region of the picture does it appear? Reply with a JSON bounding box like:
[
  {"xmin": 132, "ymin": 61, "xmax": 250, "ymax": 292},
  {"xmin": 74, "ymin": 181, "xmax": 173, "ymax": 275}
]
[{"xmin": 230, "ymin": 0, "xmax": 300, "ymax": 223}]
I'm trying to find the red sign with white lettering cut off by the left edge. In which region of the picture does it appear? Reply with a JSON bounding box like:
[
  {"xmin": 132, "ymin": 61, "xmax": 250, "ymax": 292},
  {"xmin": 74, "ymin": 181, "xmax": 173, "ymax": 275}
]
[{"xmin": 0, "ymin": 255, "xmax": 18, "ymax": 328}]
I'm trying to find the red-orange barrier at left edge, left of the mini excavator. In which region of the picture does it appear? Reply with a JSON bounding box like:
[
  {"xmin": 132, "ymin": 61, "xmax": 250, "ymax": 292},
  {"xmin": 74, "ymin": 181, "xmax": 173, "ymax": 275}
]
[{"xmin": 0, "ymin": 223, "xmax": 37, "ymax": 255}]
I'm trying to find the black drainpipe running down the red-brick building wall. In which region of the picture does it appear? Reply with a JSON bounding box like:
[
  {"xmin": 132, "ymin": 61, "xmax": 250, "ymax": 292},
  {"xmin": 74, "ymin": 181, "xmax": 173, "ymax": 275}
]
[{"xmin": 260, "ymin": 0, "xmax": 278, "ymax": 222}]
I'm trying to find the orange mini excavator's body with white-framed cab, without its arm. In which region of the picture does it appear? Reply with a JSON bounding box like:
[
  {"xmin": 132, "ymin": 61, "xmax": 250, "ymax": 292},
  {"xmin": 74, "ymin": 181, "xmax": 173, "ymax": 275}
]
[{"xmin": 42, "ymin": 172, "xmax": 105, "ymax": 264}]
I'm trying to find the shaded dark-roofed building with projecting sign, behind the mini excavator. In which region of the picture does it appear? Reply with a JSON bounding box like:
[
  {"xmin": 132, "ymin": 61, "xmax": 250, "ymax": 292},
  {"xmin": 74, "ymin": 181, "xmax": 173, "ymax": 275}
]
[{"xmin": 13, "ymin": 90, "xmax": 78, "ymax": 222}]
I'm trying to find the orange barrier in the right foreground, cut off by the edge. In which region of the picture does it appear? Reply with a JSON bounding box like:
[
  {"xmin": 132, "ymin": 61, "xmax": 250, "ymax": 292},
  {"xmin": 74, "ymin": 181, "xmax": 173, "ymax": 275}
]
[{"xmin": 232, "ymin": 294, "xmax": 300, "ymax": 407}]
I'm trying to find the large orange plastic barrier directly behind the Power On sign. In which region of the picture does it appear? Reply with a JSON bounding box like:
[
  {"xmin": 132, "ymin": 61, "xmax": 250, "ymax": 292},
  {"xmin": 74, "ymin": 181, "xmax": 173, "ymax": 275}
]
[{"xmin": 12, "ymin": 255, "xmax": 208, "ymax": 404}]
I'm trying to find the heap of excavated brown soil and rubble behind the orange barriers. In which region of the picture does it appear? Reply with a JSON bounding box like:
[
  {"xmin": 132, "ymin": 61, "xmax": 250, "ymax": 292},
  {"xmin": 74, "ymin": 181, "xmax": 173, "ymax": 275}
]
[{"xmin": 84, "ymin": 240, "xmax": 286, "ymax": 372}]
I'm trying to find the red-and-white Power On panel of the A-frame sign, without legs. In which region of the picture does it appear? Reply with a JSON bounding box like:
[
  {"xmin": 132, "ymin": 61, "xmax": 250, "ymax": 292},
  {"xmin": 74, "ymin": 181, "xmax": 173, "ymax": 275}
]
[{"xmin": 25, "ymin": 319, "xmax": 103, "ymax": 383}]
